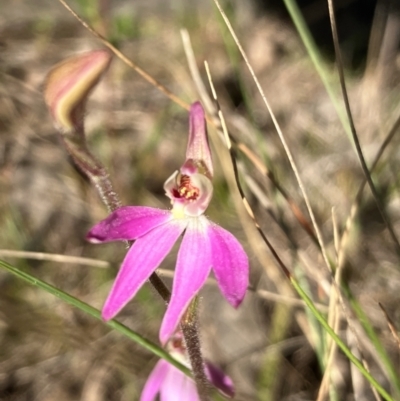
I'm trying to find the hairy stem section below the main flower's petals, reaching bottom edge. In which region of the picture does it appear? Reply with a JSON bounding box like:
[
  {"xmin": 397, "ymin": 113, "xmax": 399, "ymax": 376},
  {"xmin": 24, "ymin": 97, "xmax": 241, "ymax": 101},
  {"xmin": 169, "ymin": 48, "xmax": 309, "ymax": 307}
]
[{"xmin": 181, "ymin": 296, "xmax": 210, "ymax": 401}]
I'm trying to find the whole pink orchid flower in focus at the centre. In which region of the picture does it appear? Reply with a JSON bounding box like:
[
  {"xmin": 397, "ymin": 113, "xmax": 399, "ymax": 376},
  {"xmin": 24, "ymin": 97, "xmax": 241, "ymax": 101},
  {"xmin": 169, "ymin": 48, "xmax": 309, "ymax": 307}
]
[{"xmin": 87, "ymin": 102, "xmax": 249, "ymax": 344}]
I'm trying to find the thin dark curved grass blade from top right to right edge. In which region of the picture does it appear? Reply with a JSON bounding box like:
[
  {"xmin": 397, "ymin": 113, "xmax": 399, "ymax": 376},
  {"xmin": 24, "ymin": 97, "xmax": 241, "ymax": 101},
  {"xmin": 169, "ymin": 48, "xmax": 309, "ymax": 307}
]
[{"xmin": 328, "ymin": 0, "xmax": 400, "ymax": 252}]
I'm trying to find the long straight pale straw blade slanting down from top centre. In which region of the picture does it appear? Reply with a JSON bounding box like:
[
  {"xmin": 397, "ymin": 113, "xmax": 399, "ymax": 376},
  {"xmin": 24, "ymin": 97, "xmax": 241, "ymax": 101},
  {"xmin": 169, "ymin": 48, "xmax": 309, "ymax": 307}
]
[{"xmin": 214, "ymin": 0, "xmax": 332, "ymax": 272}]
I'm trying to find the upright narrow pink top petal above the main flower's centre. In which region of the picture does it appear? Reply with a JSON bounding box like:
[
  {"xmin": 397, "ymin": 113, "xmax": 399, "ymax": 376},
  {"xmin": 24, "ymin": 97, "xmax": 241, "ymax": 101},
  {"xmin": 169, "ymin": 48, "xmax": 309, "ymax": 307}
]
[{"xmin": 182, "ymin": 102, "xmax": 213, "ymax": 178}]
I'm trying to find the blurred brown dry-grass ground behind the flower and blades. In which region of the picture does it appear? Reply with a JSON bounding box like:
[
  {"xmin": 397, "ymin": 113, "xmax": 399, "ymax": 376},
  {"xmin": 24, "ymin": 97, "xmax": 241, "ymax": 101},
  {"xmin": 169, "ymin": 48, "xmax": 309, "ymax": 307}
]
[{"xmin": 0, "ymin": 0, "xmax": 400, "ymax": 401}]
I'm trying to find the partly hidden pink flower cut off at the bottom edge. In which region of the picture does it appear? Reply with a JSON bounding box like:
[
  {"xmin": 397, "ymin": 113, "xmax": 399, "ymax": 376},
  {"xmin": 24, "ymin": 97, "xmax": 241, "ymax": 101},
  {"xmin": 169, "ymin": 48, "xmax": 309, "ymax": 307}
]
[{"xmin": 140, "ymin": 334, "xmax": 235, "ymax": 401}]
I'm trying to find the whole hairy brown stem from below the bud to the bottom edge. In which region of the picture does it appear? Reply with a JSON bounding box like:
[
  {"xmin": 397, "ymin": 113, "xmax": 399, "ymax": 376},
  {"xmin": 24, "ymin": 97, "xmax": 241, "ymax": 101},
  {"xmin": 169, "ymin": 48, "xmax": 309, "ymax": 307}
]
[{"xmin": 61, "ymin": 127, "xmax": 209, "ymax": 394}]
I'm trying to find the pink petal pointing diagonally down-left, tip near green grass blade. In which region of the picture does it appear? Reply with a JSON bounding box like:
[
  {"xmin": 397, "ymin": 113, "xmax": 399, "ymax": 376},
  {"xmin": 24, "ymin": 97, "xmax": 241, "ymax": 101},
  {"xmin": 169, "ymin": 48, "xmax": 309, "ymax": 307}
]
[{"xmin": 102, "ymin": 220, "xmax": 187, "ymax": 320}]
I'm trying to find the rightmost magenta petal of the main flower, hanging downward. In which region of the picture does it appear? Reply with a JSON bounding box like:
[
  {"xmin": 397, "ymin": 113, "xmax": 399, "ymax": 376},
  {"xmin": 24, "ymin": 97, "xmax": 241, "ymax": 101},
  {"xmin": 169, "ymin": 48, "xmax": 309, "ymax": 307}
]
[{"xmin": 208, "ymin": 224, "xmax": 249, "ymax": 308}]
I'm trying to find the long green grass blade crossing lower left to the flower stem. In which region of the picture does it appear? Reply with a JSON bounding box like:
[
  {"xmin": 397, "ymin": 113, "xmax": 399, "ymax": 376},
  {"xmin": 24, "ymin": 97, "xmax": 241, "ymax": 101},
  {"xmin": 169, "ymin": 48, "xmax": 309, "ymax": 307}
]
[{"xmin": 0, "ymin": 260, "xmax": 191, "ymax": 376}]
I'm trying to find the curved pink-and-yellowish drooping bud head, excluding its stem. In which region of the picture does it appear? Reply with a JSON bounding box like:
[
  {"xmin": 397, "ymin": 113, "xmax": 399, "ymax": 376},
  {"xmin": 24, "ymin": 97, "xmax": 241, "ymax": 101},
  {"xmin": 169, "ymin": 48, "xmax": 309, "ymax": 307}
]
[{"xmin": 44, "ymin": 50, "xmax": 111, "ymax": 133}]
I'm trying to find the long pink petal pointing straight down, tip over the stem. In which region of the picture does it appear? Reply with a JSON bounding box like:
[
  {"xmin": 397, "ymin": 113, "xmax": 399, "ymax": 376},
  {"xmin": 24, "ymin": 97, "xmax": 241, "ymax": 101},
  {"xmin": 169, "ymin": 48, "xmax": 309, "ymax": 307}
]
[{"xmin": 160, "ymin": 216, "xmax": 211, "ymax": 344}]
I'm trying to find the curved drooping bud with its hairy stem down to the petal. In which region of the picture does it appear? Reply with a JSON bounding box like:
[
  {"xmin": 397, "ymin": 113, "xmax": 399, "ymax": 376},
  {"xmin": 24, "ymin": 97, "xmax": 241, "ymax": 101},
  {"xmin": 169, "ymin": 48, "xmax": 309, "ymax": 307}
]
[{"xmin": 44, "ymin": 50, "xmax": 121, "ymax": 211}]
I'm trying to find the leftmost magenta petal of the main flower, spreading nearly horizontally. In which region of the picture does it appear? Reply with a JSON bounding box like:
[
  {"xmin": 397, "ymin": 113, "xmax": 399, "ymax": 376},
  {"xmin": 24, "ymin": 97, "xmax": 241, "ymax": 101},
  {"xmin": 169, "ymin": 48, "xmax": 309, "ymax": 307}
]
[{"xmin": 86, "ymin": 206, "xmax": 172, "ymax": 243}]
